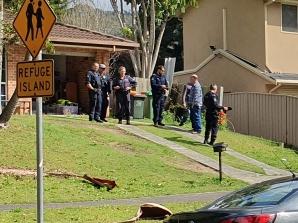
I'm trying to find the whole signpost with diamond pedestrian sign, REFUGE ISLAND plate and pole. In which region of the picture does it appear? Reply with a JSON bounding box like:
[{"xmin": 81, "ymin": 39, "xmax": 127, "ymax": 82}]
[{"xmin": 13, "ymin": 0, "xmax": 56, "ymax": 223}]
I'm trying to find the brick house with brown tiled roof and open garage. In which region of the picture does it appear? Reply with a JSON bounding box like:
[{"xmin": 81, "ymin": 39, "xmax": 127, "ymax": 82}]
[{"xmin": 0, "ymin": 23, "xmax": 139, "ymax": 114}]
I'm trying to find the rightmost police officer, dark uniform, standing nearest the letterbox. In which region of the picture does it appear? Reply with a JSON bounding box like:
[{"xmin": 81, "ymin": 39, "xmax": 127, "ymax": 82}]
[{"xmin": 204, "ymin": 84, "xmax": 228, "ymax": 145}]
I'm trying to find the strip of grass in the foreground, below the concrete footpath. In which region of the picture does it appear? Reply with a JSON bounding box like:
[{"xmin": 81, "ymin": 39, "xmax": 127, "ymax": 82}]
[{"xmin": 0, "ymin": 202, "xmax": 205, "ymax": 223}]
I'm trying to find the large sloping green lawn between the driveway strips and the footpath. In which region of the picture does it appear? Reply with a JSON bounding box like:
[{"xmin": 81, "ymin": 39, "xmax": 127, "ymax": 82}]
[{"xmin": 0, "ymin": 116, "xmax": 246, "ymax": 203}]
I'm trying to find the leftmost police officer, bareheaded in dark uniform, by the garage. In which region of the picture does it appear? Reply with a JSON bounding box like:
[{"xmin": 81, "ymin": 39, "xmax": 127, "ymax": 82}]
[{"xmin": 86, "ymin": 63, "xmax": 102, "ymax": 122}]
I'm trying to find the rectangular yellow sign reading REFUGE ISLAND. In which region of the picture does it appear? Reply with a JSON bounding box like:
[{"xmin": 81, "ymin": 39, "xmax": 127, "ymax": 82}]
[{"xmin": 17, "ymin": 60, "xmax": 54, "ymax": 98}]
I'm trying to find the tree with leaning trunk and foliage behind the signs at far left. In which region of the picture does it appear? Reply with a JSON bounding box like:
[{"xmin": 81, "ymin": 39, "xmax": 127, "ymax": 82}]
[{"xmin": 0, "ymin": 0, "xmax": 67, "ymax": 127}]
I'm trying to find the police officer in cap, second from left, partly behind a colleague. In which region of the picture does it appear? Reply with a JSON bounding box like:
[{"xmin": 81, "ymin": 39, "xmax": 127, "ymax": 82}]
[{"xmin": 98, "ymin": 64, "xmax": 111, "ymax": 122}]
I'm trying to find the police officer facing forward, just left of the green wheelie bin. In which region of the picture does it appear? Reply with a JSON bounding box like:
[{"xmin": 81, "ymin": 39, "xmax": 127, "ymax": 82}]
[{"xmin": 113, "ymin": 66, "xmax": 137, "ymax": 125}]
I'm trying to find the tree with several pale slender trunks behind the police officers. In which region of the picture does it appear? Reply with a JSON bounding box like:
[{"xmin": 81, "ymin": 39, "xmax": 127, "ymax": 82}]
[{"xmin": 110, "ymin": 0, "xmax": 198, "ymax": 78}]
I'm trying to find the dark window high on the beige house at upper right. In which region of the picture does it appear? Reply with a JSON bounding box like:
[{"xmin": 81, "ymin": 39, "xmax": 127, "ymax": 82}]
[{"xmin": 282, "ymin": 5, "xmax": 298, "ymax": 32}]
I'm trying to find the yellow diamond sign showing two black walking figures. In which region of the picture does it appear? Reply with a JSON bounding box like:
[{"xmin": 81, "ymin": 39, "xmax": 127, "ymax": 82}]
[{"xmin": 13, "ymin": 0, "xmax": 56, "ymax": 58}]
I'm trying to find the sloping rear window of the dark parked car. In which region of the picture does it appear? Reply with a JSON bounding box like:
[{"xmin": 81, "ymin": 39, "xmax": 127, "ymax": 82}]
[{"xmin": 207, "ymin": 180, "xmax": 298, "ymax": 209}]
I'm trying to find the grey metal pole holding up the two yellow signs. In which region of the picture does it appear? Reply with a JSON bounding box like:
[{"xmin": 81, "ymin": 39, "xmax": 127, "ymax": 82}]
[{"xmin": 35, "ymin": 51, "xmax": 44, "ymax": 223}]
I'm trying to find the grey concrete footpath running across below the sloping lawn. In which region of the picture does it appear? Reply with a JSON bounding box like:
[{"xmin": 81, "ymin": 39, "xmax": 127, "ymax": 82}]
[{"xmin": 0, "ymin": 192, "xmax": 228, "ymax": 212}]
